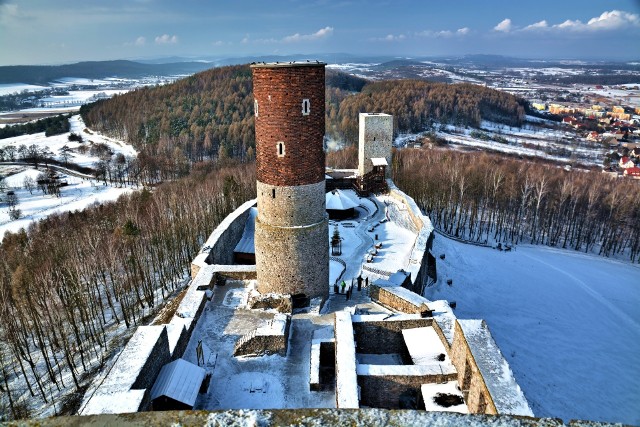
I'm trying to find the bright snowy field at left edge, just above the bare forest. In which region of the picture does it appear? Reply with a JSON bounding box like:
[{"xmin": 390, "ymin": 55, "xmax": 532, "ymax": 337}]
[{"xmin": 0, "ymin": 166, "xmax": 133, "ymax": 237}]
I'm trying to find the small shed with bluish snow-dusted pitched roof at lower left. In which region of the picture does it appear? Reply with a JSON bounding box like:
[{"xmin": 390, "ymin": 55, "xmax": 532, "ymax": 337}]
[{"xmin": 151, "ymin": 359, "xmax": 205, "ymax": 407}]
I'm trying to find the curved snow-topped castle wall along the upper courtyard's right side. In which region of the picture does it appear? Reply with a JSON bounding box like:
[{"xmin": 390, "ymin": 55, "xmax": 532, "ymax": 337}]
[{"xmin": 387, "ymin": 179, "xmax": 437, "ymax": 295}]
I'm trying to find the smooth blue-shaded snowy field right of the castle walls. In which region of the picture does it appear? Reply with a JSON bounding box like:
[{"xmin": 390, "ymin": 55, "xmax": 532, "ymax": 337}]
[{"xmin": 425, "ymin": 235, "xmax": 640, "ymax": 425}]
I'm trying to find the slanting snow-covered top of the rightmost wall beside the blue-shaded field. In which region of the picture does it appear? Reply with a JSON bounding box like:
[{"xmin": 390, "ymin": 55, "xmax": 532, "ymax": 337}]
[{"xmin": 458, "ymin": 319, "xmax": 533, "ymax": 417}]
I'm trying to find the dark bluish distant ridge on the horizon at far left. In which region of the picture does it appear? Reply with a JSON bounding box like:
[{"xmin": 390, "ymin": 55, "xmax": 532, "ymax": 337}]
[{"xmin": 0, "ymin": 60, "xmax": 213, "ymax": 84}]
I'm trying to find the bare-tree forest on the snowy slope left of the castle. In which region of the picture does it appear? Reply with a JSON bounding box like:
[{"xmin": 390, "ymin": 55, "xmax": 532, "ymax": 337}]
[{"xmin": 0, "ymin": 165, "xmax": 255, "ymax": 419}]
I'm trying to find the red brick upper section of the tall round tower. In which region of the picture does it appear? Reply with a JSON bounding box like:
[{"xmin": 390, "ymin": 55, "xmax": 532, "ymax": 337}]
[{"xmin": 251, "ymin": 63, "xmax": 325, "ymax": 186}]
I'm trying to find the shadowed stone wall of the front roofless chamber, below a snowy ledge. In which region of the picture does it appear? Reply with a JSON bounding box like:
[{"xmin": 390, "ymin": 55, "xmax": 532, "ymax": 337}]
[{"xmin": 358, "ymin": 374, "xmax": 457, "ymax": 409}]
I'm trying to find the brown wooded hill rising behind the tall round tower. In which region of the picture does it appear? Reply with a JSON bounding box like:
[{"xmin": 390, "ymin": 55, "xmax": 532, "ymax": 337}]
[{"xmin": 80, "ymin": 65, "xmax": 525, "ymax": 166}]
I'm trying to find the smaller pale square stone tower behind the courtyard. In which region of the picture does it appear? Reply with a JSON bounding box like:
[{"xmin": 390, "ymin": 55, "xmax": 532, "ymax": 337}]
[{"xmin": 358, "ymin": 113, "xmax": 393, "ymax": 177}]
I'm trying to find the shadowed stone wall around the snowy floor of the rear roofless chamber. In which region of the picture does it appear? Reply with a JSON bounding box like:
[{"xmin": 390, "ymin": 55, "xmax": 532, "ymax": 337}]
[{"xmin": 353, "ymin": 318, "xmax": 433, "ymax": 354}]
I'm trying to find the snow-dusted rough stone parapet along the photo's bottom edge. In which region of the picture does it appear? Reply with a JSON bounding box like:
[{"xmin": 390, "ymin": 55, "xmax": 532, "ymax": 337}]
[{"xmin": 18, "ymin": 409, "xmax": 611, "ymax": 427}]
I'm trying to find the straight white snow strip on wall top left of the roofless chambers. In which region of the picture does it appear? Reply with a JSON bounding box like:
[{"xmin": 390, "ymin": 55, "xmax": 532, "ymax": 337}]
[{"xmin": 335, "ymin": 311, "xmax": 360, "ymax": 408}]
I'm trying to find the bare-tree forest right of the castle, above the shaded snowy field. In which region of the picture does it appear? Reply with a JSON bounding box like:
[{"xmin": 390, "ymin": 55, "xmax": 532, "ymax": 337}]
[{"xmin": 393, "ymin": 149, "xmax": 640, "ymax": 262}]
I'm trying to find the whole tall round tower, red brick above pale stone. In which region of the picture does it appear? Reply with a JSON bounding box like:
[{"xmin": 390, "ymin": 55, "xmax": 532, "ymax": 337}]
[{"xmin": 251, "ymin": 62, "xmax": 329, "ymax": 297}]
